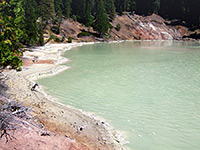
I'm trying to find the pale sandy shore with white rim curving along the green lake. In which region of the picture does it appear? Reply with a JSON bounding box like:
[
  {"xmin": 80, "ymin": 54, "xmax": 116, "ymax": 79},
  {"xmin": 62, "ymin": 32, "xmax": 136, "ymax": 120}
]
[{"xmin": 1, "ymin": 43, "xmax": 123, "ymax": 150}]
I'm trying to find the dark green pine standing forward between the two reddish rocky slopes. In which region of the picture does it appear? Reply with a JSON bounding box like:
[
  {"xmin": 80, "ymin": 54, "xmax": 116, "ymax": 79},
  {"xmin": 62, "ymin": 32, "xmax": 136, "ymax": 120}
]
[{"xmin": 93, "ymin": 0, "xmax": 110, "ymax": 37}]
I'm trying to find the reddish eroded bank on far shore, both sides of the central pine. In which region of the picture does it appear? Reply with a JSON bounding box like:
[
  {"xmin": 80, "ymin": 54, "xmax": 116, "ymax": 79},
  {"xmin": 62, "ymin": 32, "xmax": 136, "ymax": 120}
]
[{"xmin": 57, "ymin": 13, "xmax": 188, "ymax": 42}]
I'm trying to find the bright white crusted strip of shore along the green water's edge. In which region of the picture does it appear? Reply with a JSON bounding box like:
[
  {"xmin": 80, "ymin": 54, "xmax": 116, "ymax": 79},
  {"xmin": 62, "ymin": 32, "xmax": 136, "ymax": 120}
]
[{"xmin": 23, "ymin": 41, "xmax": 124, "ymax": 149}]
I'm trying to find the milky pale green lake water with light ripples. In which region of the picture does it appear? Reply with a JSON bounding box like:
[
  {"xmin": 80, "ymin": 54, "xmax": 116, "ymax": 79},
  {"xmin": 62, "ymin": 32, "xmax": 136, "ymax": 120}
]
[{"xmin": 39, "ymin": 41, "xmax": 200, "ymax": 150}]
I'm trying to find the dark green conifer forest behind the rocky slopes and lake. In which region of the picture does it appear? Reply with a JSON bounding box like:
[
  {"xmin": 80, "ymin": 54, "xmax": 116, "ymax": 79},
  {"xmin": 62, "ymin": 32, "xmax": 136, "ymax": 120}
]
[{"xmin": 0, "ymin": 0, "xmax": 200, "ymax": 69}]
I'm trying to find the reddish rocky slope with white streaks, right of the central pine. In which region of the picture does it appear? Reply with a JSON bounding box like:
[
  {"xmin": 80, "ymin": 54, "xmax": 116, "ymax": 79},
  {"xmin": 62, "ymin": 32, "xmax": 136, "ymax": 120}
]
[{"xmin": 112, "ymin": 13, "xmax": 187, "ymax": 40}]
